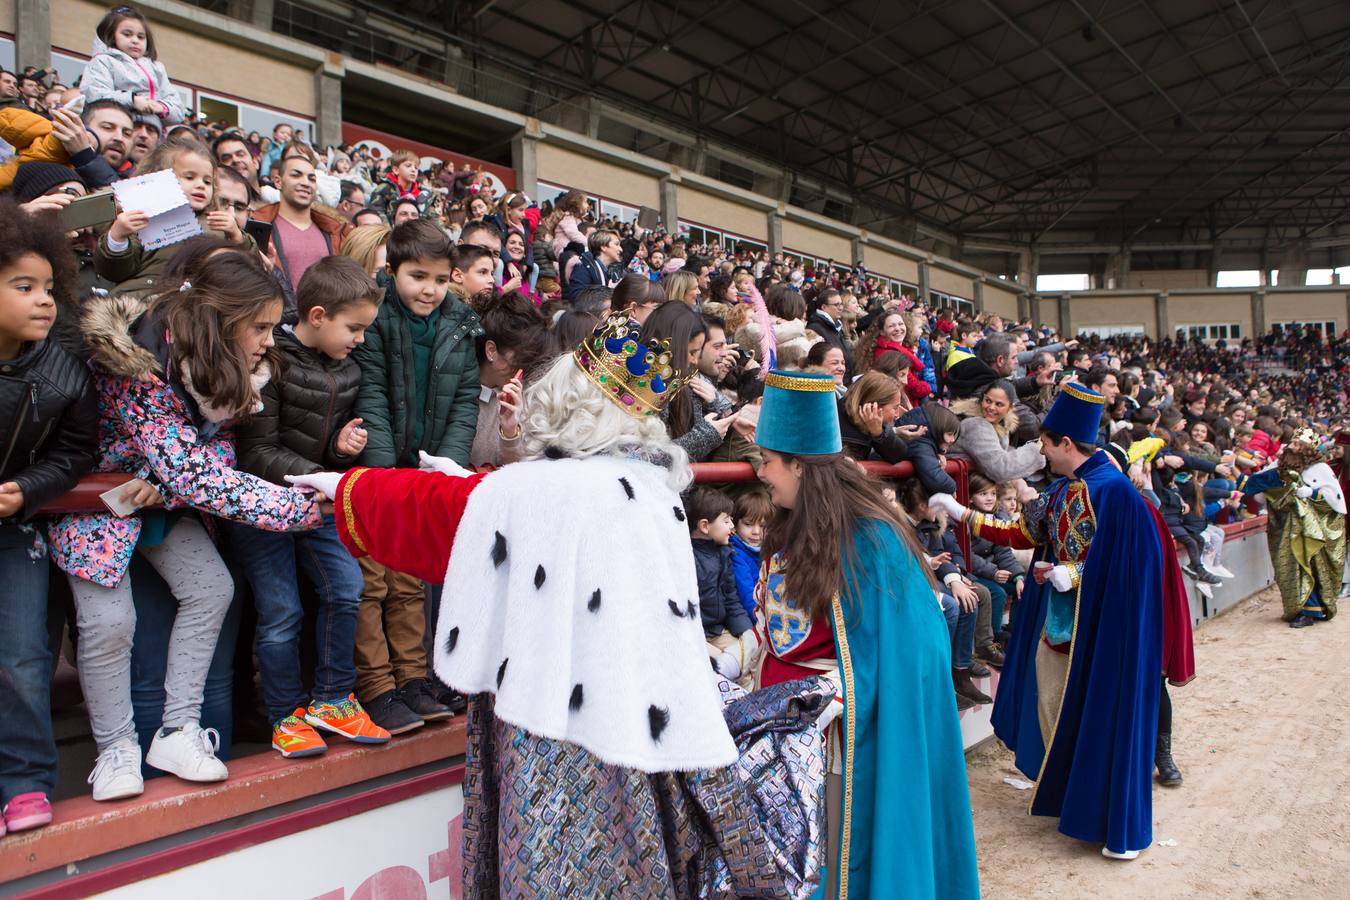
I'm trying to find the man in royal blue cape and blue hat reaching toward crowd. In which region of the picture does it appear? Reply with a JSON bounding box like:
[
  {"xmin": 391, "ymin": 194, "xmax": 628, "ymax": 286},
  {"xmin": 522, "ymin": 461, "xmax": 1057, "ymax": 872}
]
[{"xmin": 940, "ymin": 382, "xmax": 1162, "ymax": 860}]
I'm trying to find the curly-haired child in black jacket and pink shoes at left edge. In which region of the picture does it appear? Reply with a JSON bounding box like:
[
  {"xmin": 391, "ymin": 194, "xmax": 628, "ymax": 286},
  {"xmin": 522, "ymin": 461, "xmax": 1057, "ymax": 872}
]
[{"xmin": 0, "ymin": 200, "xmax": 99, "ymax": 835}]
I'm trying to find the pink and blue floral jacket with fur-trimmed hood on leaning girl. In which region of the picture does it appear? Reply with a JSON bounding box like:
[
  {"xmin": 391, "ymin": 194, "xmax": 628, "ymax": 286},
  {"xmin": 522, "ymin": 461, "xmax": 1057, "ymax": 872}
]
[{"xmin": 47, "ymin": 297, "xmax": 323, "ymax": 587}]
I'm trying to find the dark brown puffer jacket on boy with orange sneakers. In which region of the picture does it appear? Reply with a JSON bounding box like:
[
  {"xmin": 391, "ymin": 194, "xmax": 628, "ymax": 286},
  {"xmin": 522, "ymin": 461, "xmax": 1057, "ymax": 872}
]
[{"xmin": 235, "ymin": 325, "xmax": 360, "ymax": 486}]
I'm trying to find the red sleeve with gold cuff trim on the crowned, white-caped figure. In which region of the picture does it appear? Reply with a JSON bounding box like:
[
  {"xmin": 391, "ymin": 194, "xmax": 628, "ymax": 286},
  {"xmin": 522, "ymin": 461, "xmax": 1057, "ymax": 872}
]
[{"xmin": 335, "ymin": 468, "xmax": 486, "ymax": 584}]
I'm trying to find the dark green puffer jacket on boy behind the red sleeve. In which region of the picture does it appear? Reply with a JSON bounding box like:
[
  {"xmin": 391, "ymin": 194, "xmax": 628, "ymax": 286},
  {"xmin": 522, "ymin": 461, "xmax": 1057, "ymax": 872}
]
[{"xmin": 352, "ymin": 282, "xmax": 485, "ymax": 468}]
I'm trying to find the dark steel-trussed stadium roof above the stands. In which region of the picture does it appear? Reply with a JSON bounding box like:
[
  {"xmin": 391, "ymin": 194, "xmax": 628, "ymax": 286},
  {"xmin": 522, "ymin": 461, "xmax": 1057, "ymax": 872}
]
[{"xmin": 301, "ymin": 0, "xmax": 1350, "ymax": 249}]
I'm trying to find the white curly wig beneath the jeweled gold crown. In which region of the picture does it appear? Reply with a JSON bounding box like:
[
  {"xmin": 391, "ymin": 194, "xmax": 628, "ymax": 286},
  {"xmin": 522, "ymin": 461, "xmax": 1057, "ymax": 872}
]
[{"xmin": 521, "ymin": 354, "xmax": 694, "ymax": 491}]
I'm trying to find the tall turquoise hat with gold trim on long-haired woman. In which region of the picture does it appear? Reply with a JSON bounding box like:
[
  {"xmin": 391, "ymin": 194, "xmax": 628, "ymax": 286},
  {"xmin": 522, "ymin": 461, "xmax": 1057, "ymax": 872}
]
[{"xmin": 755, "ymin": 370, "xmax": 844, "ymax": 456}]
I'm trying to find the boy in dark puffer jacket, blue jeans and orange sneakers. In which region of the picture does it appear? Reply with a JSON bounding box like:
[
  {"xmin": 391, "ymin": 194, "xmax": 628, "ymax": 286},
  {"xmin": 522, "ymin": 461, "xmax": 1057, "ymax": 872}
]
[{"xmin": 231, "ymin": 256, "xmax": 389, "ymax": 760}]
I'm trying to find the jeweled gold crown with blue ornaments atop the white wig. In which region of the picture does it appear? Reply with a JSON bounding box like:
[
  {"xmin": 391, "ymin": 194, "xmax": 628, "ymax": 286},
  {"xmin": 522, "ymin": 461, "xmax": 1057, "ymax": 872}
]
[{"xmin": 572, "ymin": 316, "xmax": 694, "ymax": 418}]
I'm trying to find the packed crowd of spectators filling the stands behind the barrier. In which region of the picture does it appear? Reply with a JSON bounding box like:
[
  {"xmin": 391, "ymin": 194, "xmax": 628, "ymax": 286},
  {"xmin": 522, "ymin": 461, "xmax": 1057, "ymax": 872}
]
[{"xmin": 0, "ymin": 0, "xmax": 1350, "ymax": 847}]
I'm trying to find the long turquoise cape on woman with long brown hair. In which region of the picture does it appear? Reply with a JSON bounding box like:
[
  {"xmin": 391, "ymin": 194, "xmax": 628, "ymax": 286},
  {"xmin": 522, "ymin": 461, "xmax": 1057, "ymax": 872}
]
[{"xmin": 834, "ymin": 519, "xmax": 980, "ymax": 900}]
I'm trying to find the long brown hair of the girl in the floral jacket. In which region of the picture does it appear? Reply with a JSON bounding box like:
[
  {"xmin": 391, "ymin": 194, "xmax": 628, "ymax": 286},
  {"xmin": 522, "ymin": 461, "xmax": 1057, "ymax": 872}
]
[{"xmin": 151, "ymin": 251, "xmax": 281, "ymax": 418}]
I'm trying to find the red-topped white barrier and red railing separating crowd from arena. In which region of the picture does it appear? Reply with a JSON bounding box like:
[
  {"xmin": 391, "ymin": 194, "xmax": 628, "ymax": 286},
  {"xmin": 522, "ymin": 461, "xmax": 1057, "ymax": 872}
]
[{"xmin": 0, "ymin": 460, "xmax": 1273, "ymax": 900}]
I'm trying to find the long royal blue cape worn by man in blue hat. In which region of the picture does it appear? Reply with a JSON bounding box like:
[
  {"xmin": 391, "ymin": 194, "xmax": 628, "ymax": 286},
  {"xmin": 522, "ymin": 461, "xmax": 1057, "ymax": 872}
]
[{"xmin": 994, "ymin": 451, "xmax": 1164, "ymax": 851}]
